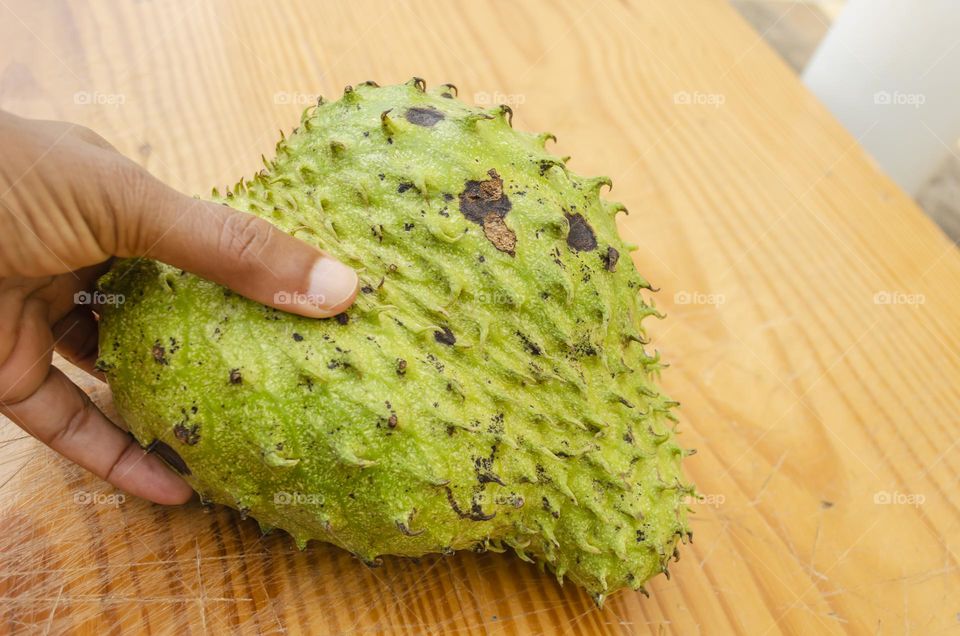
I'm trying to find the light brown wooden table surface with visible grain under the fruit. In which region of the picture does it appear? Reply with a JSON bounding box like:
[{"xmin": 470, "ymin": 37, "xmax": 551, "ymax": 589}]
[{"xmin": 0, "ymin": 0, "xmax": 960, "ymax": 635}]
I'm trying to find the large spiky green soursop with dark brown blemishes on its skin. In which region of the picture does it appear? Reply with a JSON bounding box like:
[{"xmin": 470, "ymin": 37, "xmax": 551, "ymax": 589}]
[{"xmin": 99, "ymin": 79, "xmax": 692, "ymax": 602}]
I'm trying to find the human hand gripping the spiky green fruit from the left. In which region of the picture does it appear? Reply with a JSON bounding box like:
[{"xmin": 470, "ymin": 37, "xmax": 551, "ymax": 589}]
[{"xmin": 0, "ymin": 111, "xmax": 357, "ymax": 504}]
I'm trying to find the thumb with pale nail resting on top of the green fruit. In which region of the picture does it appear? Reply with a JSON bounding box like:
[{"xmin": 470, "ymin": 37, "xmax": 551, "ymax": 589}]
[{"xmin": 117, "ymin": 175, "xmax": 358, "ymax": 318}]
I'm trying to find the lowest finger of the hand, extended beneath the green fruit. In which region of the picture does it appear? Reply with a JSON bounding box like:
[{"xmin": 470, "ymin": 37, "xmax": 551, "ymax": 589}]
[{"xmin": 0, "ymin": 367, "xmax": 193, "ymax": 504}]
